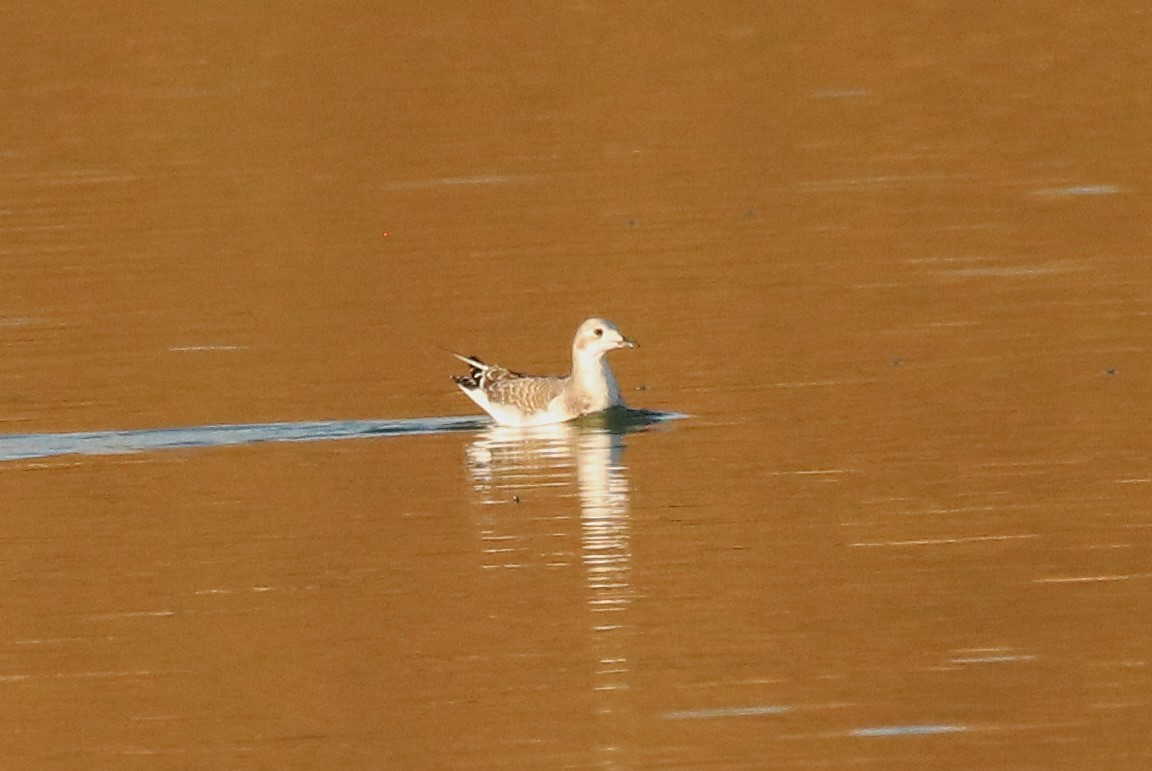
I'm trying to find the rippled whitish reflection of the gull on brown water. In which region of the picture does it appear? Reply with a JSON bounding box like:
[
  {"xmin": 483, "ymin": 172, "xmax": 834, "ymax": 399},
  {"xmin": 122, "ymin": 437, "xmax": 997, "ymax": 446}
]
[{"xmin": 468, "ymin": 411, "xmax": 676, "ymax": 766}]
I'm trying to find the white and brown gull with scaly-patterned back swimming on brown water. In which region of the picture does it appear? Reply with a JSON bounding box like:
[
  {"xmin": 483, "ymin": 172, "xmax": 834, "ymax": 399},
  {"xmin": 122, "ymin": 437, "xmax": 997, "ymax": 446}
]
[{"xmin": 448, "ymin": 317, "xmax": 636, "ymax": 426}]
